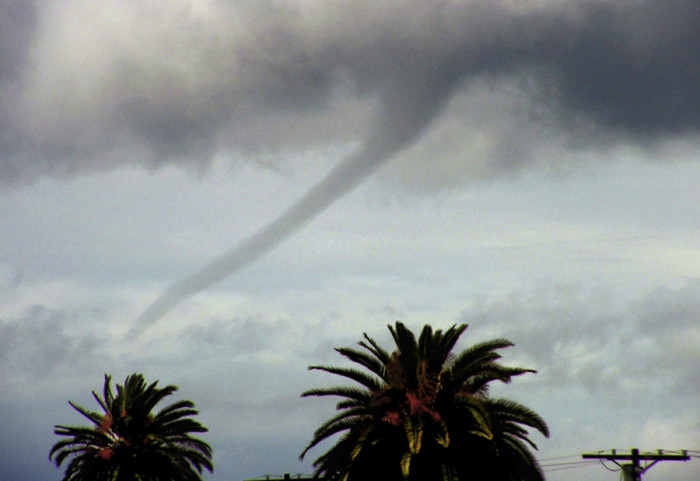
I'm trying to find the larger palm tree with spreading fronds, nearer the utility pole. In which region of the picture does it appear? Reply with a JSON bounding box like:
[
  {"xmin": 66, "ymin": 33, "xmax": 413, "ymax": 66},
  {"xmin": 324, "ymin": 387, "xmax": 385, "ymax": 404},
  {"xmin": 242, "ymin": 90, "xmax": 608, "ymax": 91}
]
[{"xmin": 301, "ymin": 322, "xmax": 549, "ymax": 481}]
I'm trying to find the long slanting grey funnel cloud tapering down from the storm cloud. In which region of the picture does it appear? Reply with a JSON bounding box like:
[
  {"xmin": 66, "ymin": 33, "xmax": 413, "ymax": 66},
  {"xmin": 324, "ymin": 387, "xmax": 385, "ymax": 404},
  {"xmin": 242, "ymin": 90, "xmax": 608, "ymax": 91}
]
[{"xmin": 129, "ymin": 69, "xmax": 454, "ymax": 338}]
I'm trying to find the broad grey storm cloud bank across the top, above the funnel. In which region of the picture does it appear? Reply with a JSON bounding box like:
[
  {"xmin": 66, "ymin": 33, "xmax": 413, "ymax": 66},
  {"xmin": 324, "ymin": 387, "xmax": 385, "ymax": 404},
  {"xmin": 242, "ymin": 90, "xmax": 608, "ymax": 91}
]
[{"xmin": 0, "ymin": 0, "xmax": 700, "ymax": 182}]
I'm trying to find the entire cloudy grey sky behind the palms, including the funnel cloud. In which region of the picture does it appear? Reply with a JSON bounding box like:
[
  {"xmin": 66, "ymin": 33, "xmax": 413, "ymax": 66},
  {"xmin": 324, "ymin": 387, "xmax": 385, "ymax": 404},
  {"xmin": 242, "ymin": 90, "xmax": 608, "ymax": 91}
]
[{"xmin": 0, "ymin": 0, "xmax": 700, "ymax": 481}]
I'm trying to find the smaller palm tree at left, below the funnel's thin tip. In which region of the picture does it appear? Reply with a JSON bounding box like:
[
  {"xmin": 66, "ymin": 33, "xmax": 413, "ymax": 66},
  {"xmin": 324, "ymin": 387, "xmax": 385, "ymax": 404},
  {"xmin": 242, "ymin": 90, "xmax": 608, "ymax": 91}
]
[{"xmin": 49, "ymin": 374, "xmax": 213, "ymax": 481}]
